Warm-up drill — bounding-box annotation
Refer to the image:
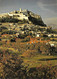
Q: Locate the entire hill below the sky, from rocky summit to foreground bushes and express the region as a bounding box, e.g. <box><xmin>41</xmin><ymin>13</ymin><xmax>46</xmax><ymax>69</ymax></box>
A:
<box><xmin>0</xmin><ymin>9</ymin><xmax>57</xmax><ymax>79</ymax></box>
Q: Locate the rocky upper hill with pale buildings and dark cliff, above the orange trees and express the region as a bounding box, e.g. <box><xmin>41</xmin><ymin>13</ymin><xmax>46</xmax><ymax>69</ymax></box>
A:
<box><xmin>0</xmin><ymin>9</ymin><xmax>53</xmax><ymax>38</ymax></box>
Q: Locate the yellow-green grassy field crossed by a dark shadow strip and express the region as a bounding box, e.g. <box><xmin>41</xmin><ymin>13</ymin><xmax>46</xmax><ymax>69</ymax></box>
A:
<box><xmin>23</xmin><ymin>55</ymin><xmax>57</xmax><ymax>68</ymax></box>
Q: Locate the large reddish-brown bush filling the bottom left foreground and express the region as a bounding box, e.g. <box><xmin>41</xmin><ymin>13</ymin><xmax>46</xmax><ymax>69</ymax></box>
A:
<box><xmin>0</xmin><ymin>49</ymin><xmax>26</xmax><ymax>79</ymax></box>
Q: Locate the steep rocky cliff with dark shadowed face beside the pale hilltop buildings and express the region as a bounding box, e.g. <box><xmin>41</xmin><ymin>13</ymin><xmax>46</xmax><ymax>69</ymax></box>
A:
<box><xmin>28</xmin><ymin>11</ymin><xmax>46</xmax><ymax>26</ymax></box>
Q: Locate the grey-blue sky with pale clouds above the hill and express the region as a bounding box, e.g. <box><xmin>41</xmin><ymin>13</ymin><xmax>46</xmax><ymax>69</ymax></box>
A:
<box><xmin>0</xmin><ymin>0</ymin><xmax>57</xmax><ymax>25</ymax></box>
